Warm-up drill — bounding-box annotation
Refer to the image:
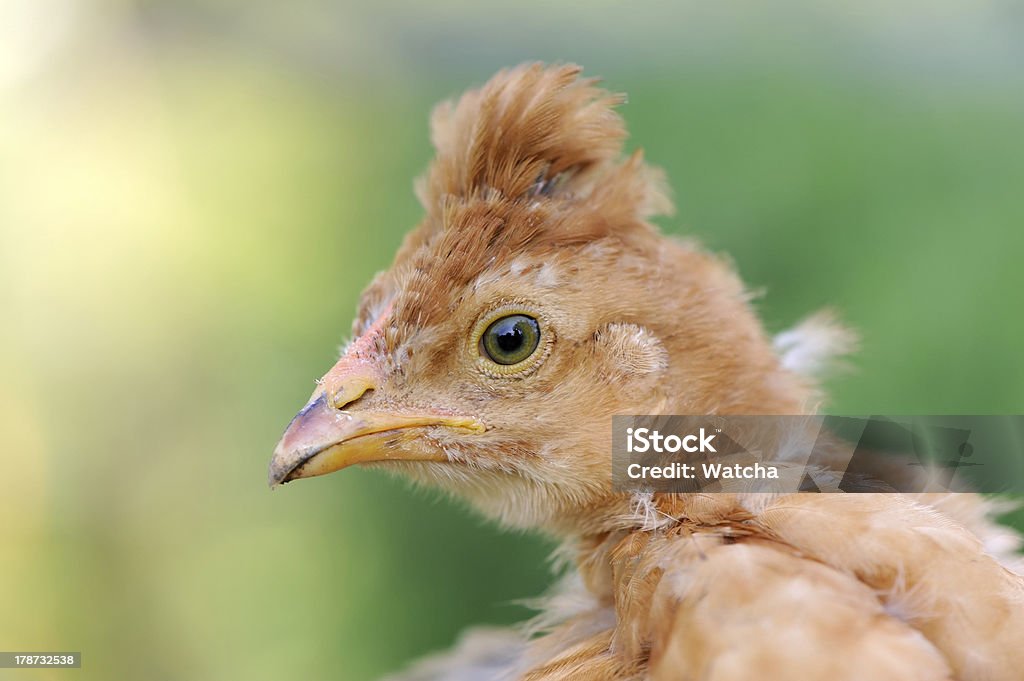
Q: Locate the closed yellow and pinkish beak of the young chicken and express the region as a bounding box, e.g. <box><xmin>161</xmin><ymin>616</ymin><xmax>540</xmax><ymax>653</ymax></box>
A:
<box><xmin>269</xmin><ymin>393</ymin><xmax>484</xmax><ymax>487</ymax></box>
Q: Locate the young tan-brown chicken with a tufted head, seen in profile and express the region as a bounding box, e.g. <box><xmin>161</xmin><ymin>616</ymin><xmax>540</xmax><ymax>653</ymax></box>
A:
<box><xmin>270</xmin><ymin>65</ymin><xmax>1024</xmax><ymax>681</ymax></box>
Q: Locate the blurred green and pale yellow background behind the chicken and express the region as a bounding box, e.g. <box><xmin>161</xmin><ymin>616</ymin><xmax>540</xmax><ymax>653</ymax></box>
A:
<box><xmin>0</xmin><ymin>0</ymin><xmax>1024</xmax><ymax>681</ymax></box>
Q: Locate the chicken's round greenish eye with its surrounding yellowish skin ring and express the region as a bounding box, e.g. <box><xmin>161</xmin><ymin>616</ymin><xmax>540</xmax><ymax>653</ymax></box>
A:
<box><xmin>470</xmin><ymin>305</ymin><xmax>553</xmax><ymax>378</ymax></box>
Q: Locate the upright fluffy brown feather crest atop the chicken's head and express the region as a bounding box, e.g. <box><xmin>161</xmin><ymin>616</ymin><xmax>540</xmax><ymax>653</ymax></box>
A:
<box><xmin>417</xmin><ymin>63</ymin><xmax>671</xmax><ymax>217</ymax></box>
